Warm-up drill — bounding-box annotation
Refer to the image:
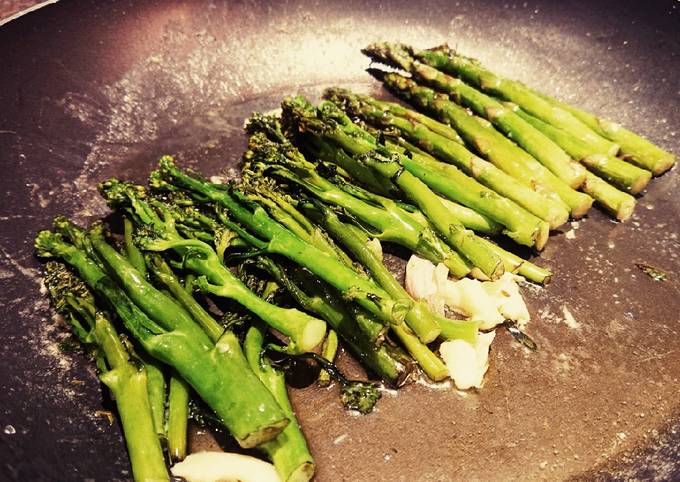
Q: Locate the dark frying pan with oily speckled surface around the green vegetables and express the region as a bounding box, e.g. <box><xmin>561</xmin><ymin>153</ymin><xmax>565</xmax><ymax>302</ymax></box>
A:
<box><xmin>0</xmin><ymin>0</ymin><xmax>680</xmax><ymax>481</ymax></box>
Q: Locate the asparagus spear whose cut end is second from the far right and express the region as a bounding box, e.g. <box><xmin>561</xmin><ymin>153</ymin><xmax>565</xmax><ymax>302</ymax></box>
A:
<box><xmin>517</xmin><ymin>108</ymin><xmax>652</xmax><ymax>194</ymax></box>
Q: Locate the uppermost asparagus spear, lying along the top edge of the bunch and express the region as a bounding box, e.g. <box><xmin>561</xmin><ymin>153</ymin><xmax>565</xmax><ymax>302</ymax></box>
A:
<box><xmin>412</xmin><ymin>46</ymin><xmax>619</xmax><ymax>155</ymax></box>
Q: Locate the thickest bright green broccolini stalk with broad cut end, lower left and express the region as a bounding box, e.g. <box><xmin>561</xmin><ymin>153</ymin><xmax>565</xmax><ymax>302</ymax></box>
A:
<box><xmin>35</xmin><ymin>224</ymin><xmax>288</xmax><ymax>447</ymax></box>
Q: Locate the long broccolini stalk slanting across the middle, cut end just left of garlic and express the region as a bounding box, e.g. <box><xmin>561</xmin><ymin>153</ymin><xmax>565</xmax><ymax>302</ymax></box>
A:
<box><xmin>151</xmin><ymin>156</ymin><xmax>410</xmax><ymax>324</ymax></box>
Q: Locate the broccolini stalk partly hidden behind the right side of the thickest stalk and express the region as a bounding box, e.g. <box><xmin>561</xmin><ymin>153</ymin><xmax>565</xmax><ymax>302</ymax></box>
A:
<box><xmin>243</xmin><ymin>322</ymin><xmax>314</xmax><ymax>482</ymax></box>
